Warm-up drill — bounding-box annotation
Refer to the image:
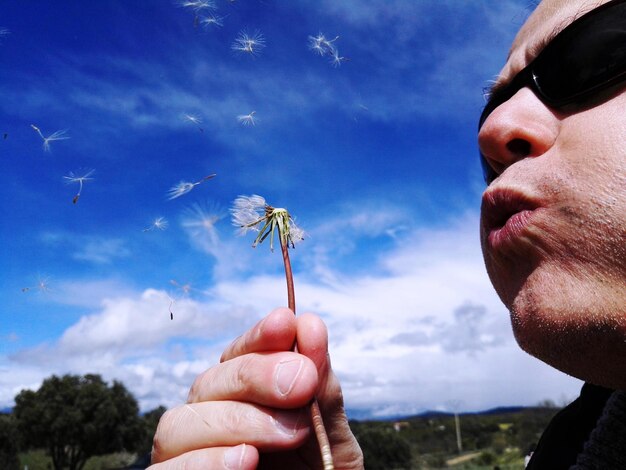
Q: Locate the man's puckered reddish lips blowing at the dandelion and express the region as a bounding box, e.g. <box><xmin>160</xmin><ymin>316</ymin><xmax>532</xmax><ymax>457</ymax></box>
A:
<box><xmin>481</xmin><ymin>188</ymin><xmax>539</xmax><ymax>251</ymax></box>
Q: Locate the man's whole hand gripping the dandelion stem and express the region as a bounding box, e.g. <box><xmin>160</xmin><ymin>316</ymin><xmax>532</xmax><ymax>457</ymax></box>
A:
<box><xmin>150</xmin><ymin>308</ymin><xmax>363</xmax><ymax>470</ymax></box>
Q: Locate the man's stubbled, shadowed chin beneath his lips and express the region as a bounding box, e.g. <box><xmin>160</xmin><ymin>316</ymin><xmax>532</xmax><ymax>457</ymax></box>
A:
<box><xmin>501</xmin><ymin>270</ymin><xmax>626</xmax><ymax>389</ymax></box>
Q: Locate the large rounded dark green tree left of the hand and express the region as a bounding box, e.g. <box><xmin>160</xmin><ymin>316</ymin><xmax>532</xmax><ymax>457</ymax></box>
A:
<box><xmin>13</xmin><ymin>374</ymin><xmax>144</xmax><ymax>470</ymax></box>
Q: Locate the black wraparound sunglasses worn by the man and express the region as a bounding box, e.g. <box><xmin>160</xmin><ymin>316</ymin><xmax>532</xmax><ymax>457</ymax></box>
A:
<box><xmin>478</xmin><ymin>0</ymin><xmax>626</xmax><ymax>184</ymax></box>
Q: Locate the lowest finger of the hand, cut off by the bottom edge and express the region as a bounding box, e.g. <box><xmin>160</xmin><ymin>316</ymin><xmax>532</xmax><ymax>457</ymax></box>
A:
<box><xmin>148</xmin><ymin>444</ymin><xmax>259</xmax><ymax>470</ymax></box>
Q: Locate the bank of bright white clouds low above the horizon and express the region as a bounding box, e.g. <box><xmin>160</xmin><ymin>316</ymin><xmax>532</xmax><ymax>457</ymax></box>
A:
<box><xmin>0</xmin><ymin>214</ymin><xmax>579</xmax><ymax>414</ymax></box>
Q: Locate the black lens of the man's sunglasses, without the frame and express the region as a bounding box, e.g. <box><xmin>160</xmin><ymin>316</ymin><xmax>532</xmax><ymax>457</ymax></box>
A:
<box><xmin>533</xmin><ymin>3</ymin><xmax>626</xmax><ymax>106</ymax></box>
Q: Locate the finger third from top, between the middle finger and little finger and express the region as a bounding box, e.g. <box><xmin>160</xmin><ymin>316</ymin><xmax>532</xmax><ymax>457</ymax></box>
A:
<box><xmin>152</xmin><ymin>401</ymin><xmax>310</xmax><ymax>463</ymax></box>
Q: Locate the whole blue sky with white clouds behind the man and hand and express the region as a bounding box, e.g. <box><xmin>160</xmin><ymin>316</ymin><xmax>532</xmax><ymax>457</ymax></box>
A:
<box><xmin>0</xmin><ymin>0</ymin><xmax>580</xmax><ymax>416</ymax></box>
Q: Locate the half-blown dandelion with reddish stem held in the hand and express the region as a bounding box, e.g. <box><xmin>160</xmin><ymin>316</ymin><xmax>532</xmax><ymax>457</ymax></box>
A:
<box><xmin>231</xmin><ymin>195</ymin><xmax>326</xmax><ymax>470</ymax></box>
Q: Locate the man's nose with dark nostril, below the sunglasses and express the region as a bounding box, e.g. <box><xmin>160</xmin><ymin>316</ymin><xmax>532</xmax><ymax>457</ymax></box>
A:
<box><xmin>478</xmin><ymin>88</ymin><xmax>559</xmax><ymax>179</ymax></box>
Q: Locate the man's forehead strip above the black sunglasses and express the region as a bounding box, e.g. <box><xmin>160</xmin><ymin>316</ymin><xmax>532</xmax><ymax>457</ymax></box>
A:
<box><xmin>499</xmin><ymin>0</ymin><xmax>610</xmax><ymax>81</ymax></box>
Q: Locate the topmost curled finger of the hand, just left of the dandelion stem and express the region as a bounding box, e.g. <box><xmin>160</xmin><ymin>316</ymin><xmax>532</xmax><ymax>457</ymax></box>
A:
<box><xmin>220</xmin><ymin>308</ymin><xmax>296</xmax><ymax>362</ymax></box>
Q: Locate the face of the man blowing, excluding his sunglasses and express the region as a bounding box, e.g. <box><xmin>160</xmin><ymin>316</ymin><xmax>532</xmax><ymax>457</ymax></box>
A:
<box><xmin>478</xmin><ymin>0</ymin><xmax>626</xmax><ymax>388</ymax></box>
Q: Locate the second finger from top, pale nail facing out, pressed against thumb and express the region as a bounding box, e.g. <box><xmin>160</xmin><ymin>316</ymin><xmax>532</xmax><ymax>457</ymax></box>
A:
<box><xmin>187</xmin><ymin>352</ymin><xmax>318</xmax><ymax>408</ymax></box>
